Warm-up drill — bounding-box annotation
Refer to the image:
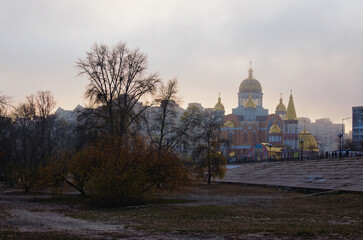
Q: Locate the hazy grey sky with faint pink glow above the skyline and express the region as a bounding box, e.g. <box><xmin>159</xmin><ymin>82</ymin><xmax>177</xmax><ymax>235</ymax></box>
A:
<box><xmin>0</xmin><ymin>0</ymin><xmax>363</xmax><ymax>130</ymax></box>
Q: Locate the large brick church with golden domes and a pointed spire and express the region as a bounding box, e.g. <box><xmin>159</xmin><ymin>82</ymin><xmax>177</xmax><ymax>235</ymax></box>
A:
<box><xmin>214</xmin><ymin>66</ymin><xmax>318</xmax><ymax>161</ymax></box>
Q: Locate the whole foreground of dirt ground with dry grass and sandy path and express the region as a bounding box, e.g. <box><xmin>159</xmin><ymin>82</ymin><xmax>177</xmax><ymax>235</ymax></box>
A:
<box><xmin>0</xmin><ymin>184</ymin><xmax>363</xmax><ymax>240</ymax></box>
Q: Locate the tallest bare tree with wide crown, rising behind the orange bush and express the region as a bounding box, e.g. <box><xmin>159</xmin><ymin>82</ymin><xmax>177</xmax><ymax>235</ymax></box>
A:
<box><xmin>76</xmin><ymin>42</ymin><xmax>159</xmax><ymax>137</ymax></box>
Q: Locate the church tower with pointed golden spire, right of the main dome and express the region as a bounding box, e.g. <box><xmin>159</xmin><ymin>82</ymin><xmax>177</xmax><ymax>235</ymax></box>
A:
<box><xmin>284</xmin><ymin>92</ymin><xmax>299</xmax><ymax>149</ymax></box>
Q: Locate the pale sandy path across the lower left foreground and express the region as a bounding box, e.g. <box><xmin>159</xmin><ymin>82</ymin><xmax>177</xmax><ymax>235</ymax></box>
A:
<box><xmin>0</xmin><ymin>187</ymin><xmax>144</xmax><ymax>239</ymax></box>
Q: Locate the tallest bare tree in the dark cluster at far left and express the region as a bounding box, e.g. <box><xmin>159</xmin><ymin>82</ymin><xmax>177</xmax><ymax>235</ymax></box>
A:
<box><xmin>13</xmin><ymin>91</ymin><xmax>56</xmax><ymax>192</ymax></box>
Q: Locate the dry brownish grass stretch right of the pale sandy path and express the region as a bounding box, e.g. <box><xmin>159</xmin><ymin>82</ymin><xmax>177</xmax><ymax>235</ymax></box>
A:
<box><xmin>62</xmin><ymin>184</ymin><xmax>363</xmax><ymax>239</ymax></box>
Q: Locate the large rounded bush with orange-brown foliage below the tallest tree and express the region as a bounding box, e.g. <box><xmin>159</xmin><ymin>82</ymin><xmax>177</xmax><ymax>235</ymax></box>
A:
<box><xmin>69</xmin><ymin>137</ymin><xmax>190</xmax><ymax>206</ymax></box>
